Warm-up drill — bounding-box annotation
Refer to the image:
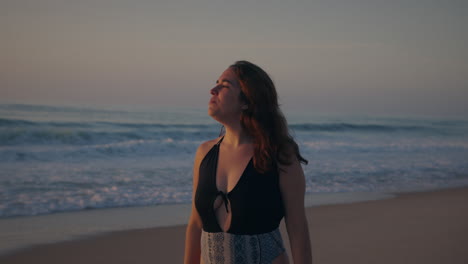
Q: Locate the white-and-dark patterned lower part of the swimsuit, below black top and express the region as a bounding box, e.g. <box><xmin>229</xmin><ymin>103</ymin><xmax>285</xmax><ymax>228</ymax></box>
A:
<box><xmin>201</xmin><ymin>228</ymin><xmax>285</xmax><ymax>264</ymax></box>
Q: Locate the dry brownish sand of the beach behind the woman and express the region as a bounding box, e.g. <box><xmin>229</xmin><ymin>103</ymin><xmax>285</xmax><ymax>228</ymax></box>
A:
<box><xmin>0</xmin><ymin>187</ymin><xmax>468</xmax><ymax>264</ymax></box>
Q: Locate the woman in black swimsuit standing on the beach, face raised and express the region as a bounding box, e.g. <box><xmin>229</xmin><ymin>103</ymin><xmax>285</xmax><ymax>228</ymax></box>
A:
<box><xmin>185</xmin><ymin>61</ymin><xmax>312</xmax><ymax>264</ymax></box>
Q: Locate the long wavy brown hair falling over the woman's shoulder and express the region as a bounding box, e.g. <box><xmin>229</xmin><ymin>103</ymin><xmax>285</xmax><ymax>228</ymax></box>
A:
<box><xmin>220</xmin><ymin>61</ymin><xmax>308</xmax><ymax>173</ymax></box>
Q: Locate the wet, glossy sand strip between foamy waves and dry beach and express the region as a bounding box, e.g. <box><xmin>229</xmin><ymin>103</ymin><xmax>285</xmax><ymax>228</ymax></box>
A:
<box><xmin>0</xmin><ymin>189</ymin><xmax>394</xmax><ymax>255</ymax></box>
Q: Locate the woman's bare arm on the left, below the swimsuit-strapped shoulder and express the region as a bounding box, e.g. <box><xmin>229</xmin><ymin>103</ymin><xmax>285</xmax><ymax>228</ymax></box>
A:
<box><xmin>184</xmin><ymin>144</ymin><xmax>203</xmax><ymax>264</ymax></box>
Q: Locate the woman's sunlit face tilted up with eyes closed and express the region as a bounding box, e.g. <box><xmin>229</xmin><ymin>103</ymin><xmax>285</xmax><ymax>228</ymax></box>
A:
<box><xmin>208</xmin><ymin>68</ymin><xmax>244</xmax><ymax>121</ymax></box>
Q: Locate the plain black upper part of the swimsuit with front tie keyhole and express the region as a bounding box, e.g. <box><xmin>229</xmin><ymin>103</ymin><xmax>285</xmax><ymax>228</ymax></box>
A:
<box><xmin>195</xmin><ymin>136</ymin><xmax>284</xmax><ymax>235</ymax></box>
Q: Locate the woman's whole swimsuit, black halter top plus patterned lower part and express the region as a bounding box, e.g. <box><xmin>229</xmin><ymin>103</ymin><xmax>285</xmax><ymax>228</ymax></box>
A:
<box><xmin>195</xmin><ymin>137</ymin><xmax>285</xmax><ymax>264</ymax></box>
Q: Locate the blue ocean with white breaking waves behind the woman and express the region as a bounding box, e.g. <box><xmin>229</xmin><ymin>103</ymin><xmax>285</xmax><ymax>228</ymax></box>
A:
<box><xmin>0</xmin><ymin>104</ymin><xmax>468</xmax><ymax>219</ymax></box>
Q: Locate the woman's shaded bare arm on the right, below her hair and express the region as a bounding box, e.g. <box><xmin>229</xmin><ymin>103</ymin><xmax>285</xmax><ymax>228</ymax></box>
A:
<box><xmin>280</xmin><ymin>157</ymin><xmax>312</xmax><ymax>264</ymax></box>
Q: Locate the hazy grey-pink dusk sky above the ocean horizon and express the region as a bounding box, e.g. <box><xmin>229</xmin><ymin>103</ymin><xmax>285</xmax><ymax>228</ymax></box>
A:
<box><xmin>0</xmin><ymin>0</ymin><xmax>468</xmax><ymax>118</ymax></box>
